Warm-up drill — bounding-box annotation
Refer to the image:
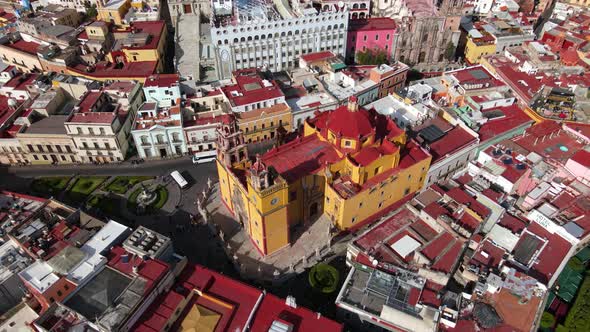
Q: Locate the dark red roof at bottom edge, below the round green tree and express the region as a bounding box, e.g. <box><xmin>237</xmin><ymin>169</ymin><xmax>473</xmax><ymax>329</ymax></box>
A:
<box><xmin>251</xmin><ymin>294</ymin><xmax>343</xmax><ymax>332</ymax></box>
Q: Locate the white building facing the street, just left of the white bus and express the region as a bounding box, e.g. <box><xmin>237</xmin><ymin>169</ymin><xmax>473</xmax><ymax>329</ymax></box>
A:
<box><xmin>131</xmin><ymin>102</ymin><xmax>188</xmax><ymax>158</ymax></box>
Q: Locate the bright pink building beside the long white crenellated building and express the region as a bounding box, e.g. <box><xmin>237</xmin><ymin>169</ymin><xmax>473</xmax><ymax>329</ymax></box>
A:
<box><xmin>346</xmin><ymin>17</ymin><xmax>396</xmax><ymax>63</ymax></box>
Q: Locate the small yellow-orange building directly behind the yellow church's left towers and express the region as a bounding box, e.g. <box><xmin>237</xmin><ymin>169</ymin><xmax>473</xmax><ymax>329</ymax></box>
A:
<box><xmin>235</xmin><ymin>103</ymin><xmax>293</xmax><ymax>143</ymax></box>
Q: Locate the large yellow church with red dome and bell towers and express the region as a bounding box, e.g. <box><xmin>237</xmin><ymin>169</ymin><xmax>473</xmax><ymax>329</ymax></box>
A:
<box><xmin>217</xmin><ymin>97</ymin><xmax>431</xmax><ymax>255</ymax></box>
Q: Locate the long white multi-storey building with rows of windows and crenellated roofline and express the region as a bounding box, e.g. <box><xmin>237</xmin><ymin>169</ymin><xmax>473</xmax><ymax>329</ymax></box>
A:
<box><xmin>211</xmin><ymin>0</ymin><xmax>348</xmax><ymax>79</ymax></box>
